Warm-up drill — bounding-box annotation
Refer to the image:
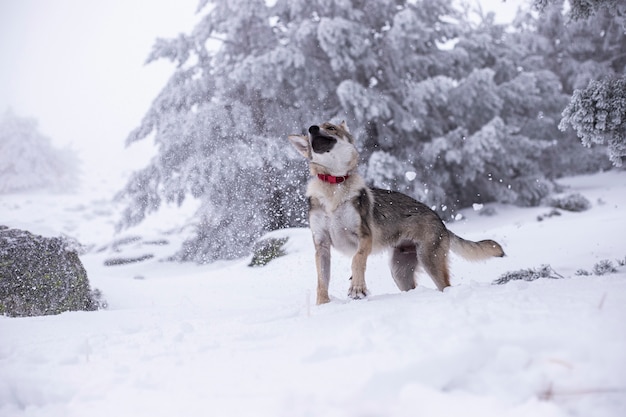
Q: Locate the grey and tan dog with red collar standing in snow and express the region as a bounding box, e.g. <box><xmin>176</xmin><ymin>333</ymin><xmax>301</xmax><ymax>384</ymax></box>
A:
<box><xmin>288</xmin><ymin>121</ymin><xmax>504</xmax><ymax>304</ymax></box>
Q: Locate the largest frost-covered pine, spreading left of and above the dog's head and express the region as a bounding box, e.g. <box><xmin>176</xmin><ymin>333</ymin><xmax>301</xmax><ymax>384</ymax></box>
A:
<box><xmin>120</xmin><ymin>0</ymin><xmax>468</xmax><ymax>262</ymax></box>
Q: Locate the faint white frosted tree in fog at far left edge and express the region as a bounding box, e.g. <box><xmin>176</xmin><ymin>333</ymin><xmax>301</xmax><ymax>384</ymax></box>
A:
<box><xmin>0</xmin><ymin>110</ymin><xmax>78</xmax><ymax>193</ymax></box>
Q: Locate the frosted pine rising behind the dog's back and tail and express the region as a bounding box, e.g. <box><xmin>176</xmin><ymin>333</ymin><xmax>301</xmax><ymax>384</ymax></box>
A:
<box><xmin>376</xmin><ymin>11</ymin><xmax>564</xmax><ymax>213</ymax></box>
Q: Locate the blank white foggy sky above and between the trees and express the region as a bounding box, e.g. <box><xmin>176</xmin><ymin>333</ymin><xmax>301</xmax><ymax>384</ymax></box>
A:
<box><xmin>0</xmin><ymin>0</ymin><xmax>525</xmax><ymax>192</ymax></box>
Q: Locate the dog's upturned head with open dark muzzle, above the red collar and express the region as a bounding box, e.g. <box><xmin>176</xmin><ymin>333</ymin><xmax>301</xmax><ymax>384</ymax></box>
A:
<box><xmin>289</xmin><ymin>122</ymin><xmax>359</xmax><ymax>176</ymax></box>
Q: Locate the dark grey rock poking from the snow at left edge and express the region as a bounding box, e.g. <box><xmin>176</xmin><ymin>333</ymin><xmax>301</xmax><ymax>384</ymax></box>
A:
<box><xmin>0</xmin><ymin>226</ymin><xmax>106</xmax><ymax>317</ymax></box>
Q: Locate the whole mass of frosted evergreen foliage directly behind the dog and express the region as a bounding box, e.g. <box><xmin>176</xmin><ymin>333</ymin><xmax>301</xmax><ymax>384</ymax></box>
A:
<box><xmin>120</xmin><ymin>0</ymin><xmax>623</xmax><ymax>262</ymax></box>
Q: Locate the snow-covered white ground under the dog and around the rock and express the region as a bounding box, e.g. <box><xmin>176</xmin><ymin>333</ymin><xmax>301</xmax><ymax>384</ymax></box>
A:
<box><xmin>0</xmin><ymin>171</ymin><xmax>626</xmax><ymax>417</ymax></box>
